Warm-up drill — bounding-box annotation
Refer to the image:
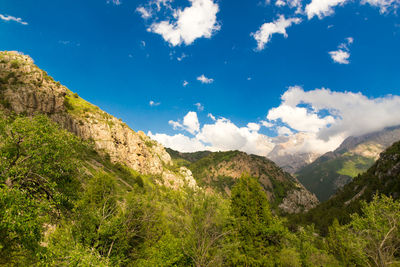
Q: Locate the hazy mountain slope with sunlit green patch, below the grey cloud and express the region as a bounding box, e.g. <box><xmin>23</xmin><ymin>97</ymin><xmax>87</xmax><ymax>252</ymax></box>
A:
<box><xmin>295</xmin><ymin>126</ymin><xmax>400</xmax><ymax>201</ymax></box>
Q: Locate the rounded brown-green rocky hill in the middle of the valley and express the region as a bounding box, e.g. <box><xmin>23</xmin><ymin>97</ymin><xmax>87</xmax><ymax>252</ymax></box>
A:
<box><xmin>167</xmin><ymin>149</ymin><xmax>318</xmax><ymax>213</ymax></box>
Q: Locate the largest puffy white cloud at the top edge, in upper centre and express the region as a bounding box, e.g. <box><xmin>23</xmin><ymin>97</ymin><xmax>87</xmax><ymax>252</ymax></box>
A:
<box><xmin>148</xmin><ymin>0</ymin><xmax>220</xmax><ymax>46</ymax></box>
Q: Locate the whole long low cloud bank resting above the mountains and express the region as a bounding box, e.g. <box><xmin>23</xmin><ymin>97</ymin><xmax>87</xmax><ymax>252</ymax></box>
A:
<box><xmin>151</xmin><ymin>86</ymin><xmax>400</xmax><ymax>159</ymax></box>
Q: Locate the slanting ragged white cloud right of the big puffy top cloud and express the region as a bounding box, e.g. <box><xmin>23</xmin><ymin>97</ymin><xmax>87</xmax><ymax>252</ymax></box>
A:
<box><xmin>251</xmin><ymin>15</ymin><xmax>301</xmax><ymax>51</ymax></box>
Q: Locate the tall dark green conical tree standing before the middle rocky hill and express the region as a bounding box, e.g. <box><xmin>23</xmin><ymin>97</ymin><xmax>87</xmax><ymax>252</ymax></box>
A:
<box><xmin>231</xmin><ymin>176</ymin><xmax>286</xmax><ymax>266</ymax></box>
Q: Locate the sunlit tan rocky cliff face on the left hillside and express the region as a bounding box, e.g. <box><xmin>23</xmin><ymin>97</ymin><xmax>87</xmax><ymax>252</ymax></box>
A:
<box><xmin>0</xmin><ymin>52</ymin><xmax>172</xmax><ymax>174</ymax></box>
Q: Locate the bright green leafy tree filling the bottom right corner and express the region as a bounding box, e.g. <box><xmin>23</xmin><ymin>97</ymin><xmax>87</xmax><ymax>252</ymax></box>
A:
<box><xmin>328</xmin><ymin>196</ymin><xmax>400</xmax><ymax>266</ymax></box>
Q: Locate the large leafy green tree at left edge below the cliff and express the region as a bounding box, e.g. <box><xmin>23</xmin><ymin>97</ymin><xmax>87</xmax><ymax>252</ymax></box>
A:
<box><xmin>0</xmin><ymin>116</ymin><xmax>84</xmax><ymax>209</ymax></box>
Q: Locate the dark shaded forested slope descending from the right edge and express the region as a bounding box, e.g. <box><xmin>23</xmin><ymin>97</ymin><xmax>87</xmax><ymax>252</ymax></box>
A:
<box><xmin>294</xmin><ymin>139</ymin><xmax>400</xmax><ymax>236</ymax></box>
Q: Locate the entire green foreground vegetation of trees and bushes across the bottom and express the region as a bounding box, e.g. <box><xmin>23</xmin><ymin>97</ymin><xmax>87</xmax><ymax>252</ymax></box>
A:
<box><xmin>0</xmin><ymin>114</ymin><xmax>400</xmax><ymax>266</ymax></box>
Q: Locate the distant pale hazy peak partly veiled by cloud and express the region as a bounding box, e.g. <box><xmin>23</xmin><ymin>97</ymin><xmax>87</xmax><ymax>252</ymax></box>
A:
<box><xmin>267</xmin><ymin>133</ymin><xmax>321</xmax><ymax>173</ymax></box>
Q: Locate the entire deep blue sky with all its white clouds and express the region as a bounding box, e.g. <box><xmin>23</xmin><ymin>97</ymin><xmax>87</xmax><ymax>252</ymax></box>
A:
<box><xmin>0</xmin><ymin>0</ymin><xmax>400</xmax><ymax>156</ymax></box>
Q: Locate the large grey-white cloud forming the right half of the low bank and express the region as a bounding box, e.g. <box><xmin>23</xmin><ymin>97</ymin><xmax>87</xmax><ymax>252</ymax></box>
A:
<box><xmin>268</xmin><ymin>86</ymin><xmax>400</xmax><ymax>141</ymax></box>
